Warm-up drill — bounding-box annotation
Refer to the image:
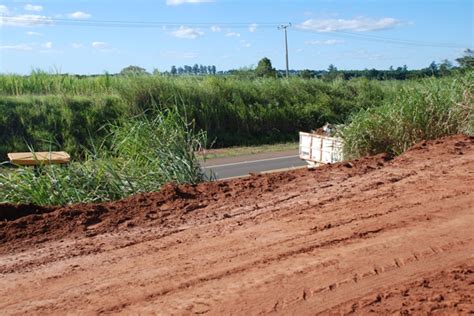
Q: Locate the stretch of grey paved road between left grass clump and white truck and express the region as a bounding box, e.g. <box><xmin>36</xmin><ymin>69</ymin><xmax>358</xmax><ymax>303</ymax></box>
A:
<box><xmin>202</xmin><ymin>150</ymin><xmax>306</xmax><ymax>179</ymax></box>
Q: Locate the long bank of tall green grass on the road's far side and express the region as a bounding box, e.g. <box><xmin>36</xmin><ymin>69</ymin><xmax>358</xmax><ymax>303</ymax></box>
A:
<box><xmin>0</xmin><ymin>71</ymin><xmax>386</xmax><ymax>161</ymax></box>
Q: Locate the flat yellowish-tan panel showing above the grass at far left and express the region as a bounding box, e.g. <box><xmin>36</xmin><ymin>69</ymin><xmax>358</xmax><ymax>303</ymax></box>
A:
<box><xmin>8</xmin><ymin>151</ymin><xmax>71</xmax><ymax>166</ymax></box>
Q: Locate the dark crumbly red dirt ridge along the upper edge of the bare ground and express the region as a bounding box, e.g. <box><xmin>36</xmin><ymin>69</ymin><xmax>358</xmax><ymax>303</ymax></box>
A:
<box><xmin>0</xmin><ymin>155</ymin><xmax>390</xmax><ymax>249</ymax></box>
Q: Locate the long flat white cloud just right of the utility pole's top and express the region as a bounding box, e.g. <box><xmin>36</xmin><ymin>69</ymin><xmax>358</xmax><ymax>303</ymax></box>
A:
<box><xmin>297</xmin><ymin>17</ymin><xmax>401</xmax><ymax>32</ymax></box>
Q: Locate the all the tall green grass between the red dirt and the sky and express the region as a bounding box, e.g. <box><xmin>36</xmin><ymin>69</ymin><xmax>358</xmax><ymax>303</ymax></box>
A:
<box><xmin>0</xmin><ymin>72</ymin><xmax>474</xmax><ymax>205</ymax></box>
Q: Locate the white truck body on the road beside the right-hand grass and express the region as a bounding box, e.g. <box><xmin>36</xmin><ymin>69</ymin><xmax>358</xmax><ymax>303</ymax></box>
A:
<box><xmin>299</xmin><ymin>132</ymin><xmax>344</xmax><ymax>167</ymax></box>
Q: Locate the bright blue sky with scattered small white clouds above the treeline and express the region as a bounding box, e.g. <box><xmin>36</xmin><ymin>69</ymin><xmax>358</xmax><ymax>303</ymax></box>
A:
<box><xmin>0</xmin><ymin>0</ymin><xmax>474</xmax><ymax>74</ymax></box>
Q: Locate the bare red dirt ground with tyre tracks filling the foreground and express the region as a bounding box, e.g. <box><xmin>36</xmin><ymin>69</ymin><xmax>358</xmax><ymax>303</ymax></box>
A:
<box><xmin>0</xmin><ymin>136</ymin><xmax>474</xmax><ymax>315</ymax></box>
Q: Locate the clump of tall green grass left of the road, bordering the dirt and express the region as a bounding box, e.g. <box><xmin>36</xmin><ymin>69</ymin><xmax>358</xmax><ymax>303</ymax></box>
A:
<box><xmin>0</xmin><ymin>110</ymin><xmax>205</xmax><ymax>205</ymax></box>
